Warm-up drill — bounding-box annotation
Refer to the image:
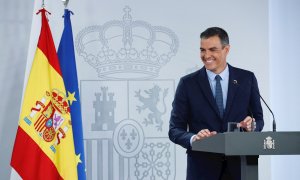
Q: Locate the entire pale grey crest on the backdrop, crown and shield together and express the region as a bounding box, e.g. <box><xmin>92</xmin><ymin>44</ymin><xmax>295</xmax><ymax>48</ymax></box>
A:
<box><xmin>76</xmin><ymin>6</ymin><xmax>179</xmax><ymax>180</ymax></box>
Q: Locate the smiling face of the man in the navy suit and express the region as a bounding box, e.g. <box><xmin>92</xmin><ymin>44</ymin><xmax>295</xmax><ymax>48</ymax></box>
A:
<box><xmin>200</xmin><ymin>36</ymin><xmax>230</xmax><ymax>74</ymax></box>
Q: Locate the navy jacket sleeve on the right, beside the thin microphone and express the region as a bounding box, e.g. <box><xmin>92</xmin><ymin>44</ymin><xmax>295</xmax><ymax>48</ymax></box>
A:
<box><xmin>250</xmin><ymin>74</ymin><xmax>264</xmax><ymax>131</ymax></box>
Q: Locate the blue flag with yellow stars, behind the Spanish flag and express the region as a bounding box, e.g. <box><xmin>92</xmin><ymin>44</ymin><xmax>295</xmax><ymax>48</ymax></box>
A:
<box><xmin>57</xmin><ymin>9</ymin><xmax>86</xmax><ymax>180</ymax></box>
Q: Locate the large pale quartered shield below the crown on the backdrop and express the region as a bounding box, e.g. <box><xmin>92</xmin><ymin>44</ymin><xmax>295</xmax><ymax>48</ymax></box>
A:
<box><xmin>81</xmin><ymin>80</ymin><xmax>175</xmax><ymax>180</ymax></box>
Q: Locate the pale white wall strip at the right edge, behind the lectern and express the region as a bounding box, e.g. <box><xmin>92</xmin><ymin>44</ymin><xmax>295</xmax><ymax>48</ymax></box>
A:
<box><xmin>269</xmin><ymin>0</ymin><xmax>300</xmax><ymax>180</ymax></box>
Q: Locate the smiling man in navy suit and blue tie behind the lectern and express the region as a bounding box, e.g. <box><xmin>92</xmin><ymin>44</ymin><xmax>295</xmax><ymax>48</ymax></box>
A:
<box><xmin>169</xmin><ymin>27</ymin><xmax>264</xmax><ymax>180</ymax></box>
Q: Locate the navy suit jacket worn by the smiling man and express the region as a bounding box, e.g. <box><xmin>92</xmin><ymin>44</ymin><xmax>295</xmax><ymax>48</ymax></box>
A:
<box><xmin>169</xmin><ymin>65</ymin><xmax>264</xmax><ymax>179</ymax></box>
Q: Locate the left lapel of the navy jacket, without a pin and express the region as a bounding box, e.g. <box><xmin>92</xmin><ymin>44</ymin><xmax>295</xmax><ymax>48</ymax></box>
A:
<box><xmin>197</xmin><ymin>67</ymin><xmax>219</xmax><ymax>115</ymax></box>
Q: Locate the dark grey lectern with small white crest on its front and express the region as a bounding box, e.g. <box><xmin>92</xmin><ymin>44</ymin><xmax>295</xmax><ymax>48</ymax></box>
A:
<box><xmin>192</xmin><ymin>132</ymin><xmax>300</xmax><ymax>180</ymax></box>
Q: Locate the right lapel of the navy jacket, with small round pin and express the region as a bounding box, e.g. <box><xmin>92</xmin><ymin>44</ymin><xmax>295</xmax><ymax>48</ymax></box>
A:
<box><xmin>224</xmin><ymin>65</ymin><xmax>239</xmax><ymax>120</ymax></box>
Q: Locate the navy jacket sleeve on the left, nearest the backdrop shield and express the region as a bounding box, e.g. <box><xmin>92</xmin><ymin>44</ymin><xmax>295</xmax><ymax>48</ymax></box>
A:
<box><xmin>169</xmin><ymin>79</ymin><xmax>194</xmax><ymax>149</ymax></box>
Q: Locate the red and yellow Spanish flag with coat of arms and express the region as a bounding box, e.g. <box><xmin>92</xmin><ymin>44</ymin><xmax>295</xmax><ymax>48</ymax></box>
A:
<box><xmin>11</xmin><ymin>8</ymin><xmax>80</xmax><ymax>180</ymax></box>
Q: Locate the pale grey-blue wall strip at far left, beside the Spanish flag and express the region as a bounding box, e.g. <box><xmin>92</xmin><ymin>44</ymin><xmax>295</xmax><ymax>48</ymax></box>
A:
<box><xmin>0</xmin><ymin>0</ymin><xmax>33</xmax><ymax>179</ymax></box>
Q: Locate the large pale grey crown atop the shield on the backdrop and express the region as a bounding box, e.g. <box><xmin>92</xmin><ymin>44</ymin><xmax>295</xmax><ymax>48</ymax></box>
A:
<box><xmin>76</xmin><ymin>6</ymin><xmax>179</xmax><ymax>79</ymax></box>
